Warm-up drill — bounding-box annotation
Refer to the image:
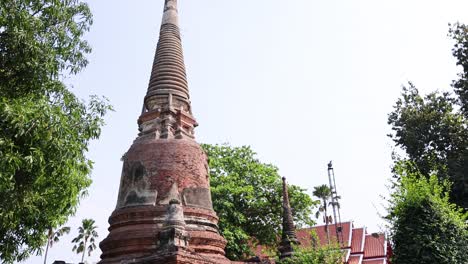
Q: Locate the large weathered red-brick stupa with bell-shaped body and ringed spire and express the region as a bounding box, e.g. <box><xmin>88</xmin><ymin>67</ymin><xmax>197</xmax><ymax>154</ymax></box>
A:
<box><xmin>99</xmin><ymin>0</ymin><xmax>231</xmax><ymax>264</ymax></box>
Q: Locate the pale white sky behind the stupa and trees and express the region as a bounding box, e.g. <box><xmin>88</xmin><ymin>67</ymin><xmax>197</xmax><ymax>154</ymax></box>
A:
<box><xmin>19</xmin><ymin>0</ymin><xmax>468</xmax><ymax>263</ymax></box>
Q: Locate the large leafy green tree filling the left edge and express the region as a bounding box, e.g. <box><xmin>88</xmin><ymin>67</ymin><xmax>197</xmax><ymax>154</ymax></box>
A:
<box><xmin>0</xmin><ymin>0</ymin><xmax>110</xmax><ymax>263</ymax></box>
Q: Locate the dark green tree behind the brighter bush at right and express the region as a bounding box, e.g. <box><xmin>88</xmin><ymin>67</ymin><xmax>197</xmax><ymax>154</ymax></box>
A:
<box><xmin>388</xmin><ymin>83</ymin><xmax>468</xmax><ymax>208</ymax></box>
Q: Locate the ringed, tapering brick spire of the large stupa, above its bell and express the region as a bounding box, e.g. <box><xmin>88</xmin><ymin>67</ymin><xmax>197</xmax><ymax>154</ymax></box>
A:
<box><xmin>138</xmin><ymin>0</ymin><xmax>197</xmax><ymax>138</ymax></box>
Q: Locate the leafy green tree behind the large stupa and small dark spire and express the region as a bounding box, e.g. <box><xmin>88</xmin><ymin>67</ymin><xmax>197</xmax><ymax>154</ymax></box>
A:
<box><xmin>202</xmin><ymin>144</ymin><xmax>316</xmax><ymax>260</ymax></box>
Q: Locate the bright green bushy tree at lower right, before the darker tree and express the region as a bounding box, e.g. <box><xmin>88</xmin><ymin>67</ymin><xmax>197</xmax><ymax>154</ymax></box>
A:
<box><xmin>386</xmin><ymin>162</ymin><xmax>468</xmax><ymax>264</ymax></box>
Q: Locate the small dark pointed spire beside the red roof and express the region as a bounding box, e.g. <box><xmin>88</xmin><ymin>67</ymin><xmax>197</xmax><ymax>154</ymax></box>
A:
<box><xmin>278</xmin><ymin>177</ymin><xmax>299</xmax><ymax>258</ymax></box>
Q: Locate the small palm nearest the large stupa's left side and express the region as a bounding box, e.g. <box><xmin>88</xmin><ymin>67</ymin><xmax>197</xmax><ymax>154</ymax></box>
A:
<box><xmin>72</xmin><ymin>219</ymin><xmax>98</xmax><ymax>262</ymax></box>
